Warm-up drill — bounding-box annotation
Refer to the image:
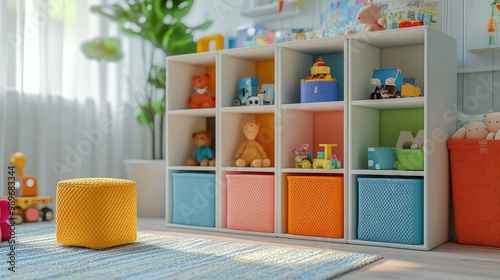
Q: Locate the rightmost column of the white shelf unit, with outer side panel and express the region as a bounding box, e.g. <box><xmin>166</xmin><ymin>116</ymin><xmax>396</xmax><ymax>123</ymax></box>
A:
<box><xmin>347</xmin><ymin>27</ymin><xmax>457</xmax><ymax>250</ymax></box>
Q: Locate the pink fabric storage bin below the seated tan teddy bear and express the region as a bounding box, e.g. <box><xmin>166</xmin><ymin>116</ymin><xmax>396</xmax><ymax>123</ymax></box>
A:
<box><xmin>226</xmin><ymin>174</ymin><xmax>274</xmax><ymax>232</ymax></box>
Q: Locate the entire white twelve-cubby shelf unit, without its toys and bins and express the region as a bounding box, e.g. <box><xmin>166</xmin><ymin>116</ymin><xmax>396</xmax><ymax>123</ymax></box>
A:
<box><xmin>166</xmin><ymin>26</ymin><xmax>456</xmax><ymax>250</ymax></box>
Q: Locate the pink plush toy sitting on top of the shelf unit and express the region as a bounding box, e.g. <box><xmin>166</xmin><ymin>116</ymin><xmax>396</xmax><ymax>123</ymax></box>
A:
<box><xmin>345</xmin><ymin>0</ymin><xmax>387</xmax><ymax>35</ymax></box>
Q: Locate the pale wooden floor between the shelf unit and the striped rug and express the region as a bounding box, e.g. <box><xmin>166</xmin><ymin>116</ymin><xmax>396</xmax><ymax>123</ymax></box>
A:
<box><xmin>138</xmin><ymin>218</ymin><xmax>500</xmax><ymax>280</ymax></box>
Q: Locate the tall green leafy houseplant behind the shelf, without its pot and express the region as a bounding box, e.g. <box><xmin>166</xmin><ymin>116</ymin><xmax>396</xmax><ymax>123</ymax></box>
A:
<box><xmin>82</xmin><ymin>0</ymin><xmax>212</xmax><ymax>159</ymax></box>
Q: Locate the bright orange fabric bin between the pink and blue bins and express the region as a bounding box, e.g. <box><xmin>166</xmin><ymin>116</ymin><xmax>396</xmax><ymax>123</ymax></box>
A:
<box><xmin>287</xmin><ymin>176</ymin><xmax>344</xmax><ymax>238</ymax></box>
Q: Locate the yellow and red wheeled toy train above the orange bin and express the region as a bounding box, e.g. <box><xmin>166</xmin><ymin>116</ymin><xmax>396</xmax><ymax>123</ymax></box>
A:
<box><xmin>292</xmin><ymin>144</ymin><xmax>342</xmax><ymax>169</ymax></box>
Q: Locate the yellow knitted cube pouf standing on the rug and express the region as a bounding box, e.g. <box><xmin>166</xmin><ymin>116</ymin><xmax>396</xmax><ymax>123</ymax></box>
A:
<box><xmin>56</xmin><ymin>178</ymin><xmax>137</xmax><ymax>249</ymax></box>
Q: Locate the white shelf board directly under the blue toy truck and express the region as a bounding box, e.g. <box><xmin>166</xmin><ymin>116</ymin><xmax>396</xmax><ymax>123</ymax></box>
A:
<box><xmin>351</xmin><ymin>97</ymin><xmax>425</xmax><ymax>109</ymax></box>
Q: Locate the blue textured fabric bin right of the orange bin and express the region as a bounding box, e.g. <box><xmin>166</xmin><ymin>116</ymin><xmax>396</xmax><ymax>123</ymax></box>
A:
<box><xmin>358</xmin><ymin>177</ymin><xmax>424</xmax><ymax>245</ymax></box>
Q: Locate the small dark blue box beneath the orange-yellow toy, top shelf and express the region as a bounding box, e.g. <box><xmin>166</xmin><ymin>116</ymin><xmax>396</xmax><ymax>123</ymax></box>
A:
<box><xmin>300</xmin><ymin>81</ymin><xmax>339</xmax><ymax>103</ymax></box>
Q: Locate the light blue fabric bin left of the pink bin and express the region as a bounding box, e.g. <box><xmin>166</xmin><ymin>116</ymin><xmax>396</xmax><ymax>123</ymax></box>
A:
<box><xmin>172</xmin><ymin>172</ymin><xmax>215</xmax><ymax>227</ymax></box>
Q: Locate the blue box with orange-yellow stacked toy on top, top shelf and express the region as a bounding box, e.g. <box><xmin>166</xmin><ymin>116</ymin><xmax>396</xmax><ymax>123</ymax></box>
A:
<box><xmin>300</xmin><ymin>56</ymin><xmax>339</xmax><ymax>103</ymax></box>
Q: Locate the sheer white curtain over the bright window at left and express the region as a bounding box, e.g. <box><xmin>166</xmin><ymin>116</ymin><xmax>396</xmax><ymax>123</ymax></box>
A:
<box><xmin>0</xmin><ymin>0</ymin><xmax>150</xmax><ymax>200</ymax></box>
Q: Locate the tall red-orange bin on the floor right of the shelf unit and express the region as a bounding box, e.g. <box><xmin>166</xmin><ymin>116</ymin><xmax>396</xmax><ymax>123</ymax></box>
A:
<box><xmin>447</xmin><ymin>140</ymin><xmax>500</xmax><ymax>247</ymax></box>
